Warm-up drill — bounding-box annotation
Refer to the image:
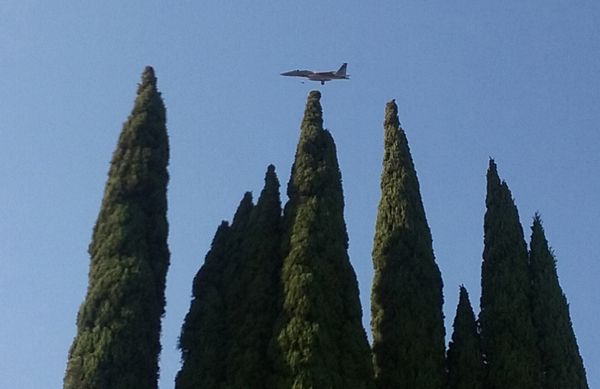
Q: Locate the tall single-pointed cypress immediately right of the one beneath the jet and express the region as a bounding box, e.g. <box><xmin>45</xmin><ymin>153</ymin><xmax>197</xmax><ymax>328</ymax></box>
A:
<box><xmin>371</xmin><ymin>100</ymin><xmax>445</xmax><ymax>389</ymax></box>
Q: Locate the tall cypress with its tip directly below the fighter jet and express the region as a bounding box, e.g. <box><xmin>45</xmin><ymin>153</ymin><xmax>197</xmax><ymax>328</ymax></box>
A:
<box><xmin>275</xmin><ymin>91</ymin><xmax>372</xmax><ymax>389</ymax></box>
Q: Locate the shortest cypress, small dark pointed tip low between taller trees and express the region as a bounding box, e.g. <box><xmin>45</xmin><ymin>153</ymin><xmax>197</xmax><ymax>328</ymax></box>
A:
<box><xmin>447</xmin><ymin>286</ymin><xmax>483</xmax><ymax>389</ymax></box>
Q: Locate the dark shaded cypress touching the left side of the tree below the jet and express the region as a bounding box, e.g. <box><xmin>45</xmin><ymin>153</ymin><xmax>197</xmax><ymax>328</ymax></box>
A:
<box><xmin>225</xmin><ymin>165</ymin><xmax>281</xmax><ymax>389</ymax></box>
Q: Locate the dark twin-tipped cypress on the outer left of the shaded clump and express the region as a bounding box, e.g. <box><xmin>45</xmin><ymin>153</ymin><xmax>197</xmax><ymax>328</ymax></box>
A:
<box><xmin>175</xmin><ymin>193</ymin><xmax>254</xmax><ymax>389</ymax></box>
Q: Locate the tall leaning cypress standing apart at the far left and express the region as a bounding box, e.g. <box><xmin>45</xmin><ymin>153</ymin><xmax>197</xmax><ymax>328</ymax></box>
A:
<box><xmin>64</xmin><ymin>67</ymin><xmax>169</xmax><ymax>389</ymax></box>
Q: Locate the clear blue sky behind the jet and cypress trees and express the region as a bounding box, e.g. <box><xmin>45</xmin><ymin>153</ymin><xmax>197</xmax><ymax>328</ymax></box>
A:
<box><xmin>0</xmin><ymin>0</ymin><xmax>600</xmax><ymax>389</ymax></box>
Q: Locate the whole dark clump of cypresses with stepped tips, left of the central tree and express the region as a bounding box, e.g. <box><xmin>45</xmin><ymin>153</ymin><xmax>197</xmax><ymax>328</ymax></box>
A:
<box><xmin>176</xmin><ymin>166</ymin><xmax>281</xmax><ymax>389</ymax></box>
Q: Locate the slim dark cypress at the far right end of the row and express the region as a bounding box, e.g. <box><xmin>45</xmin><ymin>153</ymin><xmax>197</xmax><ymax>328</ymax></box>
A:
<box><xmin>529</xmin><ymin>214</ymin><xmax>588</xmax><ymax>389</ymax></box>
